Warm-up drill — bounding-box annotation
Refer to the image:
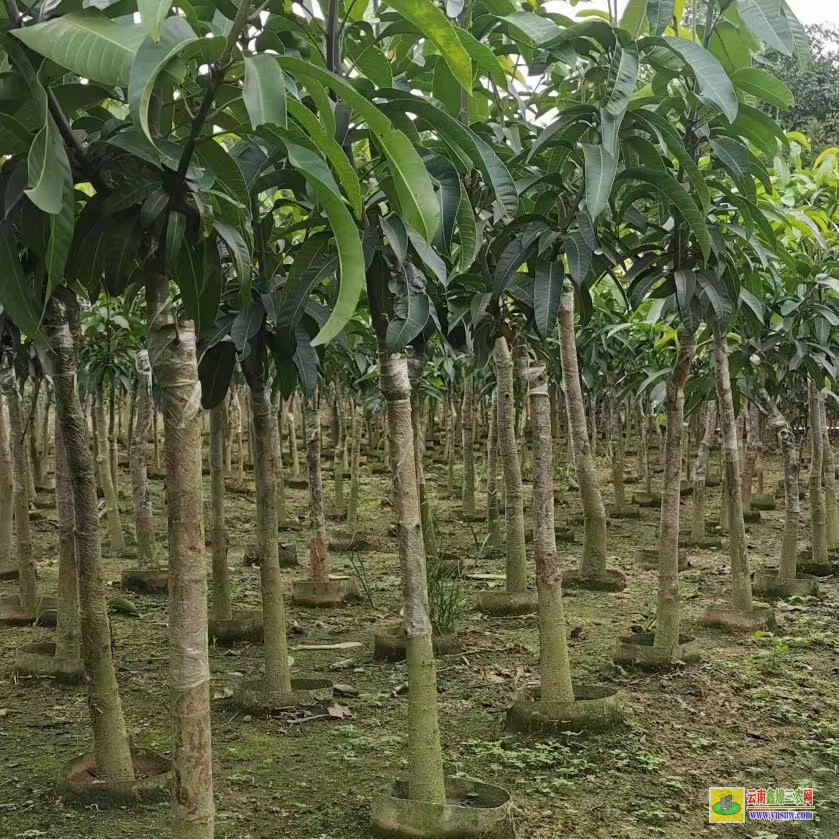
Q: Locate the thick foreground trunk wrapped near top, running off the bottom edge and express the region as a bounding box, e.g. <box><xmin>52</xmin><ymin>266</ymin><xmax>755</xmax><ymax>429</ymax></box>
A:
<box><xmin>146</xmin><ymin>272</ymin><xmax>212</xmax><ymax>839</ymax></box>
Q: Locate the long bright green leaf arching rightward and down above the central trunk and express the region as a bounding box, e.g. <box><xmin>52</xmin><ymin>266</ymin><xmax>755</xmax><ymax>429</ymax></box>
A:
<box><xmin>277</xmin><ymin>55</ymin><xmax>440</xmax><ymax>242</ymax></box>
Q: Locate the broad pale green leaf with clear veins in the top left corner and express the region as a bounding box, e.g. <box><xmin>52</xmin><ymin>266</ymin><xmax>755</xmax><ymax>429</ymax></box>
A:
<box><xmin>12</xmin><ymin>9</ymin><xmax>146</xmax><ymax>87</ymax></box>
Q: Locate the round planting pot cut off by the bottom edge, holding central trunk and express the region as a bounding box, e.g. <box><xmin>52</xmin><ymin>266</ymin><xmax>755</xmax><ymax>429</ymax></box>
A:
<box><xmin>372</xmin><ymin>778</ymin><xmax>516</xmax><ymax>839</ymax></box>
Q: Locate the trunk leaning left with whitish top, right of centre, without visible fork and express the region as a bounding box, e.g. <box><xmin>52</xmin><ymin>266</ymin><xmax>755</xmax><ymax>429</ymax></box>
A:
<box><xmin>559</xmin><ymin>280</ymin><xmax>606</xmax><ymax>579</ymax></box>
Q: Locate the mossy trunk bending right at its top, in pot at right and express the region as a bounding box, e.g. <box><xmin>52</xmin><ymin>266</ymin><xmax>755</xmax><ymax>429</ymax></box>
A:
<box><xmin>654</xmin><ymin>330</ymin><xmax>696</xmax><ymax>661</ymax></box>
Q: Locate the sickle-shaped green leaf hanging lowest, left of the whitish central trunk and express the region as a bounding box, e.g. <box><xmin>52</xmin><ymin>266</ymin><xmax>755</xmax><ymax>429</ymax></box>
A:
<box><xmin>287</xmin><ymin>143</ymin><xmax>364</xmax><ymax>347</ymax></box>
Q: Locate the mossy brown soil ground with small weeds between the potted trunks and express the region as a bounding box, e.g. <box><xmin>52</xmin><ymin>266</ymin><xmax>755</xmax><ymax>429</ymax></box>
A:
<box><xmin>0</xmin><ymin>436</ymin><xmax>839</xmax><ymax>839</ymax></box>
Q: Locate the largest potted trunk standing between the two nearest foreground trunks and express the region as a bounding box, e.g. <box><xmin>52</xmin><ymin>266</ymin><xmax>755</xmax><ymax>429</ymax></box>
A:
<box><xmin>248</xmin><ymin>370</ymin><xmax>291</xmax><ymax>703</ymax></box>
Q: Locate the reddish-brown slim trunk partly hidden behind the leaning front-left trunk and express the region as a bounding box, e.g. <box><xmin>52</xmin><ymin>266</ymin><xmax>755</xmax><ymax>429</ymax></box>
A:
<box><xmin>55</xmin><ymin>423</ymin><xmax>82</xmax><ymax>661</ymax></box>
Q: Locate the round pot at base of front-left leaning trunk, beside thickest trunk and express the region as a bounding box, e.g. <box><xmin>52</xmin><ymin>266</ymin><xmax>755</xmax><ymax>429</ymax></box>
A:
<box><xmin>56</xmin><ymin>749</ymin><xmax>172</xmax><ymax>806</ymax></box>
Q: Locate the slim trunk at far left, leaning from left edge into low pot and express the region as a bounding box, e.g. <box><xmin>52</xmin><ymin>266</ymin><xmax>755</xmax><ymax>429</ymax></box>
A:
<box><xmin>0</xmin><ymin>363</ymin><xmax>38</xmax><ymax>617</ymax></box>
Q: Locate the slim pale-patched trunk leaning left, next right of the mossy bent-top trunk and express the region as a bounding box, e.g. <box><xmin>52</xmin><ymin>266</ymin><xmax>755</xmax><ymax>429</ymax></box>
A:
<box><xmin>714</xmin><ymin>334</ymin><xmax>752</xmax><ymax>613</ymax></box>
